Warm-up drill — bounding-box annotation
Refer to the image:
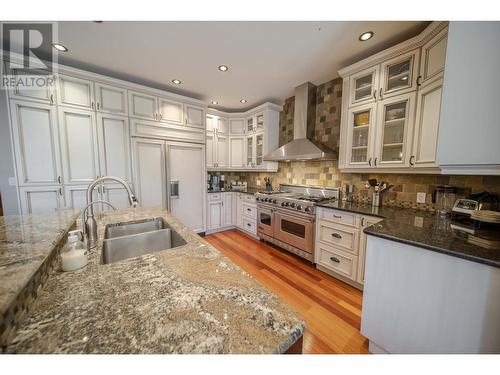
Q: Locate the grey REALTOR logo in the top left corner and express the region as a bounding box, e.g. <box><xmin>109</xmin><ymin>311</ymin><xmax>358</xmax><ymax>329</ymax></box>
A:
<box><xmin>0</xmin><ymin>22</ymin><xmax>57</xmax><ymax>92</ymax></box>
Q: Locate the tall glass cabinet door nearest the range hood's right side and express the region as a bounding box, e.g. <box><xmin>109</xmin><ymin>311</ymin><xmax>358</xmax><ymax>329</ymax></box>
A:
<box><xmin>347</xmin><ymin>103</ymin><xmax>376</xmax><ymax>168</ymax></box>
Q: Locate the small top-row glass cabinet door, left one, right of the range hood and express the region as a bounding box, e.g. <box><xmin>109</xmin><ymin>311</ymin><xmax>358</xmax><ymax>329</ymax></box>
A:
<box><xmin>349</xmin><ymin>66</ymin><xmax>379</xmax><ymax>107</ymax></box>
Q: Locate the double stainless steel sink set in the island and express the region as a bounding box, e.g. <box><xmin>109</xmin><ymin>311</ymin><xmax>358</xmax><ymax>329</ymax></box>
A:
<box><xmin>102</xmin><ymin>217</ymin><xmax>186</xmax><ymax>264</ymax></box>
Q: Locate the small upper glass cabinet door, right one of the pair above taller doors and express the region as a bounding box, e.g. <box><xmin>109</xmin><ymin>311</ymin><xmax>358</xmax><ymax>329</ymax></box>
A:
<box><xmin>377</xmin><ymin>51</ymin><xmax>418</xmax><ymax>99</ymax></box>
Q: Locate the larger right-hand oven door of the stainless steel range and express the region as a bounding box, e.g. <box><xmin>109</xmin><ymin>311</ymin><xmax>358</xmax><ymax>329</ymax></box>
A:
<box><xmin>274</xmin><ymin>211</ymin><xmax>314</xmax><ymax>254</ymax></box>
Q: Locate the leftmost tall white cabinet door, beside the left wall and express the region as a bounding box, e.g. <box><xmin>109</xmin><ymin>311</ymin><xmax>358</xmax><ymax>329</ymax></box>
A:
<box><xmin>10</xmin><ymin>100</ymin><xmax>62</xmax><ymax>185</ymax></box>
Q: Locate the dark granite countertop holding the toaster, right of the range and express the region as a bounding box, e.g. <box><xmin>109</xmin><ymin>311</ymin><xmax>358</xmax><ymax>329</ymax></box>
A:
<box><xmin>319</xmin><ymin>201</ymin><xmax>500</xmax><ymax>267</ymax></box>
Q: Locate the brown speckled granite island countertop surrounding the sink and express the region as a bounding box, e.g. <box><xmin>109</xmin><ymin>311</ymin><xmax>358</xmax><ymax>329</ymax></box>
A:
<box><xmin>6</xmin><ymin>209</ymin><xmax>305</xmax><ymax>353</ymax></box>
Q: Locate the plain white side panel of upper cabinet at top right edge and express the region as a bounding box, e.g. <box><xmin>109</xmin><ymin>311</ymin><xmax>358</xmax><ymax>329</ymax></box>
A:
<box><xmin>437</xmin><ymin>22</ymin><xmax>500</xmax><ymax>167</ymax></box>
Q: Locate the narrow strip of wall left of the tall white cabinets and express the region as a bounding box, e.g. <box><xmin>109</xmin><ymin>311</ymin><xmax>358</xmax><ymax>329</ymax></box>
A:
<box><xmin>0</xmin><ymin>89</ymin><xmax>19</xmax><ymax>215</ymax></box>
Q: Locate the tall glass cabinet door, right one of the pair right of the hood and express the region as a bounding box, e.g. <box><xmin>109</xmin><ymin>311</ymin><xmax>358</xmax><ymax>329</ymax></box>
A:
<box><xmin>373</xmin><ymin>93</ymin><xmax>416</xmax><ymax>168</ymax></box>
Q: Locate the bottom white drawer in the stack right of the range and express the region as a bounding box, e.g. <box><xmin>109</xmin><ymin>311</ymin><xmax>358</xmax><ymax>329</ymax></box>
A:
<box><xmin>316</xmin><ymin>243</ymin><xmax>358</xmax><ymax>280</ymax></box>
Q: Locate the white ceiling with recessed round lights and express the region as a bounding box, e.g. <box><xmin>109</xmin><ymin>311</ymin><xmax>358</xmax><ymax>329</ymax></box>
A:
<box><xmin>51</xmin><ymin>21</ymin><xmax>428</xmax><ymax>111</ymax></box>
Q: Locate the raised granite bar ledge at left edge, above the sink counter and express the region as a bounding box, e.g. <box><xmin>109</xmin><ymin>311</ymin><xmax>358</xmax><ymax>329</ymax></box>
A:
<box><xmin>0</xmin><ymin>210</ymin><xmax>78</xmax><ymax>318</ymax></box>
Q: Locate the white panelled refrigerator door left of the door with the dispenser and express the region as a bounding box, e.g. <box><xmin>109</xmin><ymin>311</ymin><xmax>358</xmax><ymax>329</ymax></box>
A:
<box><xmin>132</xmin><ymin>138</ymin><xmax>167</xmax><ymax>208</ymax></box>
